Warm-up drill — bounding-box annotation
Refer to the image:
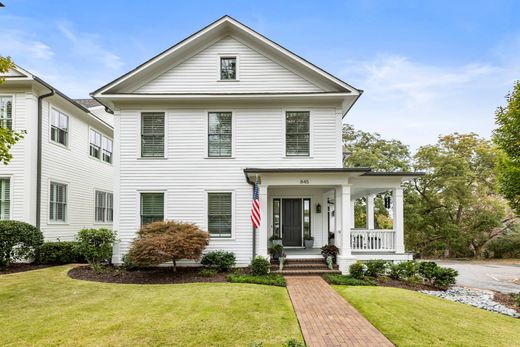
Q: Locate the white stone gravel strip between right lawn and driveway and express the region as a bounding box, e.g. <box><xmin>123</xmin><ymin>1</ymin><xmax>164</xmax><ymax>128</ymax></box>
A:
<box><xmin>420</xmin><ymin>287</ymin><xmax>520</xmax><ymax>318</ymax></box>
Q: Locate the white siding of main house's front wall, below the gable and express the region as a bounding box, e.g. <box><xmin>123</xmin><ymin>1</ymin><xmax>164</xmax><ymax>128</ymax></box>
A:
<box><xmin>114</xmin><ymin>105</ymin><xmax>341</xmax><ymax>265</ymax></box>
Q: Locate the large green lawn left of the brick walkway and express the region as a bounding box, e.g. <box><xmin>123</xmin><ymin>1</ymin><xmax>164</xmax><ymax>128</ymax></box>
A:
<box><xmin>0</xmin><ymin>266</ymin><xmax>302</xmax><ymax>346</ymax></box>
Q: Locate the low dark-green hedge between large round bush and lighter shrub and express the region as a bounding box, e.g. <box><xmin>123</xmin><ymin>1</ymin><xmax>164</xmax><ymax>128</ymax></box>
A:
<box><xmin>36</xmin><ymin>241</ymin><xmax>85</xmax><ymax>264</ymax></box>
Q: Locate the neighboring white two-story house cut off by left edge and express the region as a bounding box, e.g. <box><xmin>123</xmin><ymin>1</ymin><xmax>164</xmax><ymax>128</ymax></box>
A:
<box><xmin>0</xmin><ymin>67</ymin><xmax>114</xmax><ymax>241</ymax></box>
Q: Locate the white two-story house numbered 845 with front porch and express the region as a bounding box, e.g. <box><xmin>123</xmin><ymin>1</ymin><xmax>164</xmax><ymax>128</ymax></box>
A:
<box><xmin>92</xmin><ymin>16</ymin><xmax>420</xmax><ymax>272</ymax></box>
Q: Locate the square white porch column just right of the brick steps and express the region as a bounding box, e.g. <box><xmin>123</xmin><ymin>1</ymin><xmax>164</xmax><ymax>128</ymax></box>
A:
<box><xmin>336</xmin><ymin>184</ymin><xmax>355</xmax><ymax>274</ymax></box>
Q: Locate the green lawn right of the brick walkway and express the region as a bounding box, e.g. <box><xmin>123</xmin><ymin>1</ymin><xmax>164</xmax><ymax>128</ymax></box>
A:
<box><xmin>334</xmin><ymin>286</ymin><xmax>520</xmax><ymax>347</ymax></box>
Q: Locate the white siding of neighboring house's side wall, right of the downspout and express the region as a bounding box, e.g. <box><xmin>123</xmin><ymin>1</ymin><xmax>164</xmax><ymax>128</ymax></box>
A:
<box><xmin>41</xmin><ymin>97</ymin><xmax>113</xmax><ymax>241</ymax></box>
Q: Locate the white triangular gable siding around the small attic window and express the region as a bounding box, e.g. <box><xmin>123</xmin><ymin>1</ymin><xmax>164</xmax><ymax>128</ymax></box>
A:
<box><xmin>134</xmin><ymin>36</ymin><xmax>323</xmax><ymax>93</ymax></box>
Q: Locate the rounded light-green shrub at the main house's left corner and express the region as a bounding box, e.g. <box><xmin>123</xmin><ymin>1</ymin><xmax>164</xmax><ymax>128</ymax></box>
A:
<box><xmin>76</xmin><ymin>228</ymin><xmax>116</xmax><ymax>271</ymax></box>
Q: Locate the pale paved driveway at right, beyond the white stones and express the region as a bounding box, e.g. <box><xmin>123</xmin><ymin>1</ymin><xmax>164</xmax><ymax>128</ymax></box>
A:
<box><xmin>436</xmin><ymin>260</ymin><xmax>520</xmax><ymax>293</ymax></box>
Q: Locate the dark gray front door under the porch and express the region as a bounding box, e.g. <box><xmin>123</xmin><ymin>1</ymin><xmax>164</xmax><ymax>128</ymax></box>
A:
<box><xmin>282</xmin><ymin>199</ymin><xmax>302</xmax><ymax>247</ymax></box>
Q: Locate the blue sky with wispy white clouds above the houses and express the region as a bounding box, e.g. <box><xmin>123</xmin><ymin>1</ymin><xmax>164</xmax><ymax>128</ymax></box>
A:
<box><xmin>0</xmin><ymin>0</ymin><xmax>520</xmax><ymax>149</ymax></box>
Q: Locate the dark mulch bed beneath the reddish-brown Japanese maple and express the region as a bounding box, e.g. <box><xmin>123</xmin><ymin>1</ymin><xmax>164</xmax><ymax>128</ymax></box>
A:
<box><xmin>68</xmin><ymin>265</ymin><xmax>228</xmax><ymax>284</ymax></box>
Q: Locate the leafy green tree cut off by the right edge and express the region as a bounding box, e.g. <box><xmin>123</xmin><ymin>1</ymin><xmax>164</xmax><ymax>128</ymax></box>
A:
<box><xmin>493</xmin><ymin>81</ymin><xmax>520</xmax><ymax>213</ymax></box>
